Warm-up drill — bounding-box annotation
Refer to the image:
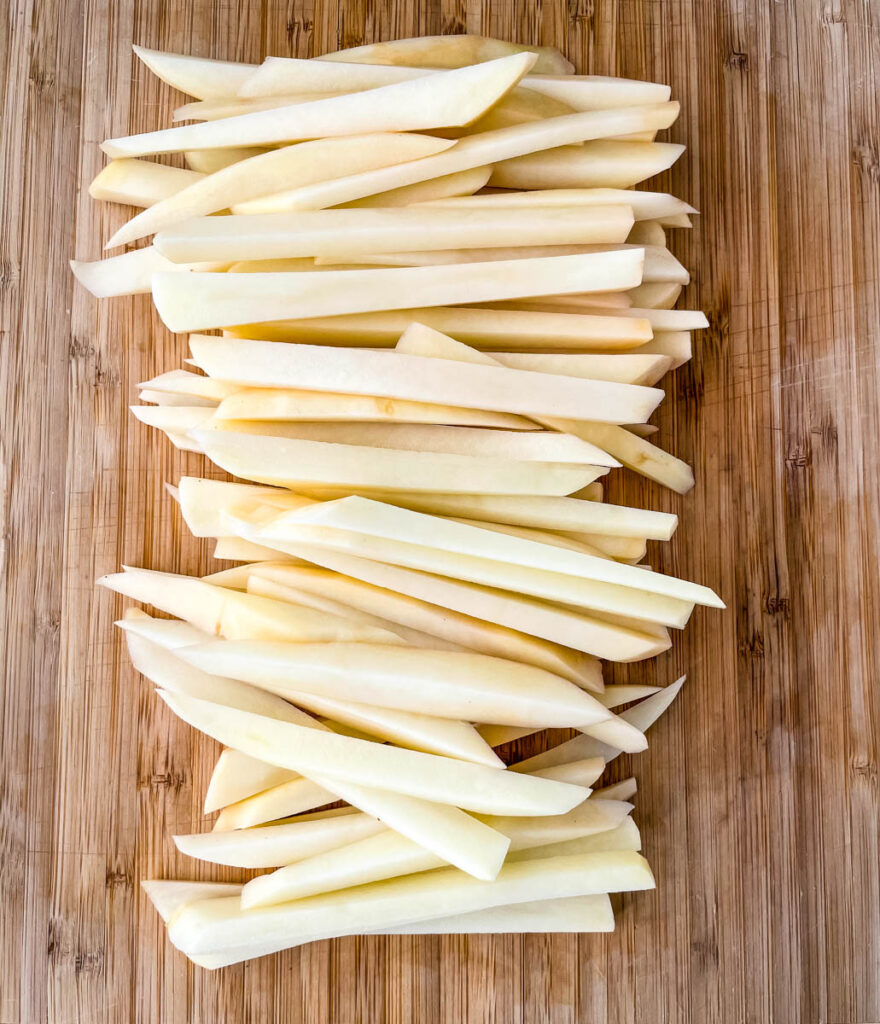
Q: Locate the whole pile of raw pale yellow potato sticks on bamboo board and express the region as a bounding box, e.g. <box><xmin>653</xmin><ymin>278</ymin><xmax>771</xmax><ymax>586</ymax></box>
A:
<box><xmin>73</xmin><ymin>36</ymin><xmax>723</xmax><ymax>968</ymax></box>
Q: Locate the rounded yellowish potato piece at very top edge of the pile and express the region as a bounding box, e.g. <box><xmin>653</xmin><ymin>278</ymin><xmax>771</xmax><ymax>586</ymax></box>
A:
<box><xmin>318</xmin><ymin>34</ymin><xmax>575</xmax><ymax>75</ymax></box>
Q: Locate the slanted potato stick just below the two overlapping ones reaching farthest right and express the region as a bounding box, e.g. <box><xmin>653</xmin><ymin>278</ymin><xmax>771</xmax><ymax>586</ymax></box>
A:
<box><xmin>233</xmin><ymin>545</ymin><xmax>669</xmax><ymax>662</ymax></box>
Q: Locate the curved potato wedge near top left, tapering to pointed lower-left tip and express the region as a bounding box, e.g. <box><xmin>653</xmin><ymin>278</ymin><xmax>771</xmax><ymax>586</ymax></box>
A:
<box><xmin>107</xmin><ymin>132</ymin><xmax>451</xmax><ymax>248</ymax></box>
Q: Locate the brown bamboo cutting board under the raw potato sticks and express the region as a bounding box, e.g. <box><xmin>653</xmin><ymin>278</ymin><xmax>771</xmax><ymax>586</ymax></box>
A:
<box><xmin>0</xmin><ymin>0</ymin><xmax>880</xmax><ymax>1024</ymax></box>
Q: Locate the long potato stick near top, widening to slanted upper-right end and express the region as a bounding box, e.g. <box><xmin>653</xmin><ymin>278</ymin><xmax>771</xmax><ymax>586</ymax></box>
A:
<box><xmin>101</xmin><ymin>54</ymin><xmax>534</xmax><ymax>157</ymax></box>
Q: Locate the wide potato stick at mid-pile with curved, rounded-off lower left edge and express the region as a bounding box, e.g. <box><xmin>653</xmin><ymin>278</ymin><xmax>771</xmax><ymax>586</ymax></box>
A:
<box><xmin>192</xmin><ymin>430</ymin><xmax>603</xmax><ymax>495</ymax></box>
